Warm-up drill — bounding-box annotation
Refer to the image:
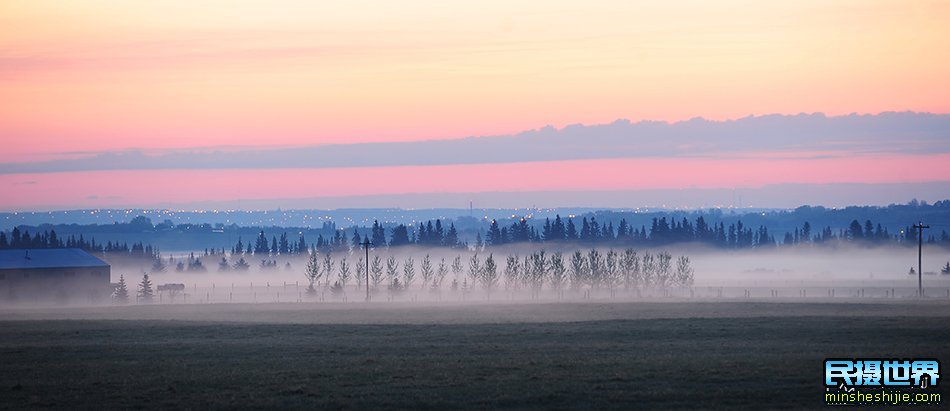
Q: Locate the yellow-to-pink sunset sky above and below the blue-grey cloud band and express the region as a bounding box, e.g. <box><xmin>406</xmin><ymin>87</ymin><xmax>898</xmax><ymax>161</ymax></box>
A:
<box><xmin>0</xmin><ymin>0</ymin><xmax>950</xmax><ymax>209</ymax></box>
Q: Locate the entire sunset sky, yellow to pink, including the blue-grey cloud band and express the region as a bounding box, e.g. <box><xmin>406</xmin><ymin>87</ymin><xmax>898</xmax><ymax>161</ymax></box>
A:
<box><xmin>0</xmin><ymin>0</ymin><xmax>950</xmax><ymax>210</ymax></box>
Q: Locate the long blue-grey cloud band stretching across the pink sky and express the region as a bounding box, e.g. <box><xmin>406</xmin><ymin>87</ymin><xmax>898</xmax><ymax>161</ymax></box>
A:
<box><xmin>0</xmin><ymin>112</ymin><xmax>950</xmax><ymax>174</ymax></box>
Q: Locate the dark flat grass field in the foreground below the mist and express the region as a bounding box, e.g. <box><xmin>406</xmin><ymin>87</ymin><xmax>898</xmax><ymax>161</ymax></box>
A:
<box><xmin>0</xmin><ymin>302</ymin><xmax>950</xmax><ymax>409</ymax></box>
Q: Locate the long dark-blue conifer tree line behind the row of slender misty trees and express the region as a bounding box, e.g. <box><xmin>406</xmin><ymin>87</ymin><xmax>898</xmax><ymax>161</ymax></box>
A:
<box><xmin>232</xmin><ymin>215</ymin><xmax>950</xmax><ymax>255</ymax></box>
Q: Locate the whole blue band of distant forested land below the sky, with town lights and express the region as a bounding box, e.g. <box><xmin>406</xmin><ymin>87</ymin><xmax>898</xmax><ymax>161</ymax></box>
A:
<box><xmin>0</xmin><ymin>200</ymin><xmax>950</xmax><ymax>259</ymax></box>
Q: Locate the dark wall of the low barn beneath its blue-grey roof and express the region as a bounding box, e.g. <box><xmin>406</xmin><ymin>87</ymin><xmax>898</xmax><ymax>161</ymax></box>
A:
<box><xmin>0</xmin><ymin>266</ymin><xmax>112</xmax><ymax>303</ymax></box>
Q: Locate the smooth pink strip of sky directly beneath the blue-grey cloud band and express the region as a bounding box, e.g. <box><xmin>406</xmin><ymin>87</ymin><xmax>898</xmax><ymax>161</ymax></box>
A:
<box><xmin>0</xmin><ymin>154</ymin><xmax>950</xmax><ymax>209</ymax></box>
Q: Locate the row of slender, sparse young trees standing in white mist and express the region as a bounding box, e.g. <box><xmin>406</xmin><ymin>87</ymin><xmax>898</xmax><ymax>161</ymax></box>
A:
<box><xmin>304</xmin><ymin>248</ymin><xmax>694</xmax><ymax>298</ymax></box>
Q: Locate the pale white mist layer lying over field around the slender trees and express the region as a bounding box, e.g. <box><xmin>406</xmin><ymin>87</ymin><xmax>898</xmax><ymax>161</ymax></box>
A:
<box><xmin>67</xmin><ymin>244</ymin><xmax>950</xmax><ymax>304</ymax></box>
